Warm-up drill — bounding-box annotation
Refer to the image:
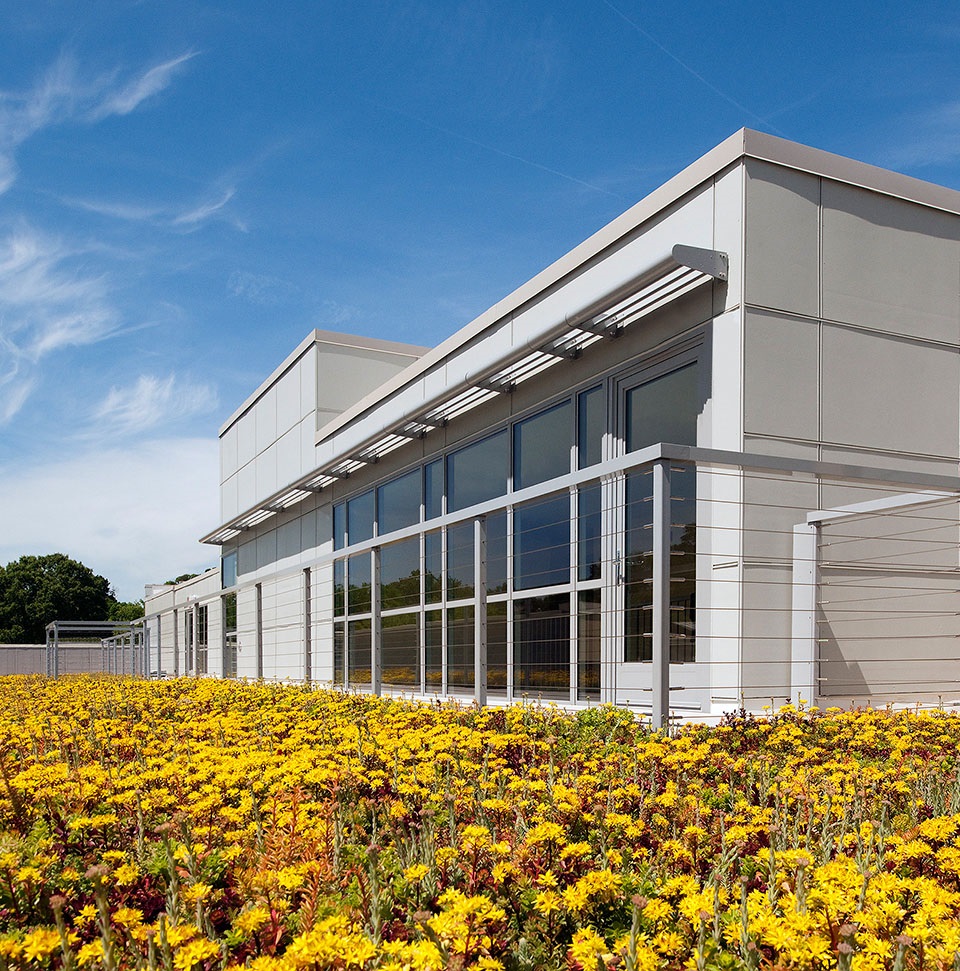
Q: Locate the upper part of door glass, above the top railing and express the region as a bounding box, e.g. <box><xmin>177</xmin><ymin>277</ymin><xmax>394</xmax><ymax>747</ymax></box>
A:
<box><xmin>626</xmin><ymin>364</ymin><xmax>700</xmax><ymax>452</ymax></box>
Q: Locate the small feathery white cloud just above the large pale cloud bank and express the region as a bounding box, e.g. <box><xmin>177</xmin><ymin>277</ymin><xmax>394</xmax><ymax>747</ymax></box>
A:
<box><xmin>91</xmin><ymin>374</ymin><xmax>218</xmax><ymax>436</ymax></box>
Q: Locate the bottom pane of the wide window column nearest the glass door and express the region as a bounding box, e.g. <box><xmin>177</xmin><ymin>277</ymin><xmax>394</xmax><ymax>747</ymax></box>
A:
<box><xmin>513</xmin><ymin>593</ymin><xmax>570</xmax><ymax>699</ymax></box>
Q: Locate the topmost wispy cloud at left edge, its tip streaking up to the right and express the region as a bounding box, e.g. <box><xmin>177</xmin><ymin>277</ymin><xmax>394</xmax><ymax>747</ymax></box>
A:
<box><xmin>0</xmin><ymin>51</ymin><xmax>198</xmax><ymax>194</ymax></box>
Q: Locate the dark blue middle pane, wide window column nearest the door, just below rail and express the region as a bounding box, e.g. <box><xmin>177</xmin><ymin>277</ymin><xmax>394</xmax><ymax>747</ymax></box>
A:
<box><xmin>513</xmin><ymin>493</ymin><xmax>570</xmax><ymax>590</ymax></box>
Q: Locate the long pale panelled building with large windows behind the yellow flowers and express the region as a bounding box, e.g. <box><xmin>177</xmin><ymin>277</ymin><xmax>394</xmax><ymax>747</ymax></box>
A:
<box><xmin>147</xmin><ymin>130</ymin><xmax>960</xmax><ymax>721</ymax></box>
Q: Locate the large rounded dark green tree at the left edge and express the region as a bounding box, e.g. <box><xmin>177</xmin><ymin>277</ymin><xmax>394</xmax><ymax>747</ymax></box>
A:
<box><xmin>0</xmin><ymin>553</ymin><xmax>116</xmax><ymax>644</ymax></box>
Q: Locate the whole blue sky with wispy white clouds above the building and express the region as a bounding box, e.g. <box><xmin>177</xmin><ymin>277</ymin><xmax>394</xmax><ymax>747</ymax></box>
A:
<box><xmin>0</xmin><ymin>0</ymin><xmax>960</xmax><ymax>599</ymax></box>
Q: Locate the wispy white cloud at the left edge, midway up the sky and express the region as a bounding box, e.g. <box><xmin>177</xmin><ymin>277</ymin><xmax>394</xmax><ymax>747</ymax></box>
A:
<box><xmin>0</xmin><ymin>226</ymin><xmax>121</xmax><ymax>422</ymax></box>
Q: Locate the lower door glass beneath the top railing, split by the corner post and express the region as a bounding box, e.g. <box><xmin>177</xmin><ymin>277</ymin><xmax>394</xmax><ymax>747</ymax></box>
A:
<box><xmin>624</xmin><ymin>466</ymin><xmax>697</xmax><ymax>664</ymax></box>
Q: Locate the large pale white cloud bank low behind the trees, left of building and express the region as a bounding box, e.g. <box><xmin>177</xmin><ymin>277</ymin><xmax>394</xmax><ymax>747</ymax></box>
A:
<box><xmin>0</xmin><ymin>438</ymin><xmax>219</xmax><ymax>600</ymax></box>
